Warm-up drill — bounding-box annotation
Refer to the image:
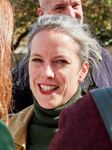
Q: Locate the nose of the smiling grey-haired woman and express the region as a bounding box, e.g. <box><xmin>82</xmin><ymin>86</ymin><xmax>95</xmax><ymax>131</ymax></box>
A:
<box><xmin>41</xmin><ymin>65</ymin><xmax>54</xmax><ymax>79</ymax></box>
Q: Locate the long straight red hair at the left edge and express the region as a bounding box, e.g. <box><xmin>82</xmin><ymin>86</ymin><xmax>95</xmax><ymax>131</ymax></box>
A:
<box><xmin>0</xmin><ymin>0</ymin><xmax>13</xmax><ymax>121</ymax></box>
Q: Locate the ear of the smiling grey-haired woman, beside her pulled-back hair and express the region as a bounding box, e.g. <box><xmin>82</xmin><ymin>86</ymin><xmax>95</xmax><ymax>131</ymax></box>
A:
<box><xmin>78</xmin><ymin>61</ymin><xmax>89</xmax><ymax>83</ymax></box>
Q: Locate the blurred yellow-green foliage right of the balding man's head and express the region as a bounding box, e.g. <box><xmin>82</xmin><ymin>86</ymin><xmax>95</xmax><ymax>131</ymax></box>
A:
<box><xmin>82</xmin><ymin>0</ymin><xmax>112</xmax><ymax>45</ymax></box>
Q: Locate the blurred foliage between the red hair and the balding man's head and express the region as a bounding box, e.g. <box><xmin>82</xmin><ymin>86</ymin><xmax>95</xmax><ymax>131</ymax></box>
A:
<box><xmin>11</xmin><ymin>0</ymin><xmax>39</xmax><ymax>49</ymax></box>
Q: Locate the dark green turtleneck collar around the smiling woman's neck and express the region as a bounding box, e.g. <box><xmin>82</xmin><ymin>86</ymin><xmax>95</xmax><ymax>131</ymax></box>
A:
<box><xmin>33</xmin><ymin>86</ymin><xmax>81</xmax><ymax>127</ymax></box>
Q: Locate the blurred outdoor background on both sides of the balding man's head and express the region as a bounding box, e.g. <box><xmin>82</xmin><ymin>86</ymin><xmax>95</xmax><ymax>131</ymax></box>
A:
<box><xmin>11</xmin><ymin>0</ymin><xmax>112</xmax><ymax>67</ymax></box>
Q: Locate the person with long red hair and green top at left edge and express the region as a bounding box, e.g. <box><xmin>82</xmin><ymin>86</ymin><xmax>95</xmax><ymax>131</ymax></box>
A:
<box><xmin>0</xmin><ymin>0</ymin><xmax>15</xmax><ymax>150</ymax></box>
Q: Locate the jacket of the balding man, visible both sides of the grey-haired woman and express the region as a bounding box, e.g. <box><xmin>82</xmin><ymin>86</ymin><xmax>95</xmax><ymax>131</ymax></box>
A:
<box><xmin>12</xmin><ymin>48</ymin><xmax>112</xmax><ymax>113</ymax></box>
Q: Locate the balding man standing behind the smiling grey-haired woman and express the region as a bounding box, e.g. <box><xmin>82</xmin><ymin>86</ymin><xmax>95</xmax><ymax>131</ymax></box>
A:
<box><xmin>12</xmin><ymin>0</ymin><xmax>112</xmax><ymax>113</ymax></box>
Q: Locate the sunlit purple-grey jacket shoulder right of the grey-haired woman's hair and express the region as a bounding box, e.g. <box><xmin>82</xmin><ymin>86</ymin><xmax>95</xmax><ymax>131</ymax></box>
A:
<box><xmin>92</xmin><ymin>48</ymin><xmax>112</xmax><ymax>88</ymax></box>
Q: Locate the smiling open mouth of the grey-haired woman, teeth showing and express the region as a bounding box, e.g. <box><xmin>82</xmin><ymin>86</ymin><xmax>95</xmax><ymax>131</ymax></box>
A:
<box><xmin>39</xmin><ymin>84</ymin><xmax>59</xmax><ymax>92</ymax></box>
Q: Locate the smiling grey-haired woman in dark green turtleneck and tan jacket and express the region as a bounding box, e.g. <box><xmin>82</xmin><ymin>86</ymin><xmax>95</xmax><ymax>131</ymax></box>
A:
<box><xmin>10</xmin><ymin>15</ymin><xmax>99</xmax><ymax>150</ymax></box>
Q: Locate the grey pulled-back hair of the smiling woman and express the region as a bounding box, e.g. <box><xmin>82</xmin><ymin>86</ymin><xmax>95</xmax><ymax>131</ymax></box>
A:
<box><xmin>15</xmin><ymin>15</ymin><xmax>100</xmax><ymax>91</ymax></box>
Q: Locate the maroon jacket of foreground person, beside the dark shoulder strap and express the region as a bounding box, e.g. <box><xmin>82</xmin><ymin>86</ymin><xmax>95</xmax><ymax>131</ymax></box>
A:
<box><xmin>49</xmin><ymin>95</ymin><xmax>112</xmax><ymax>150</ymax></box>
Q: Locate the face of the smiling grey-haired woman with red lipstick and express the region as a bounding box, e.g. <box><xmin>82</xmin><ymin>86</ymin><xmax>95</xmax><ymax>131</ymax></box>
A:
<box><xmin>29</xmin><ymin>30</ymin><xmax>87</xmax><ymax>109</ymax></box>
